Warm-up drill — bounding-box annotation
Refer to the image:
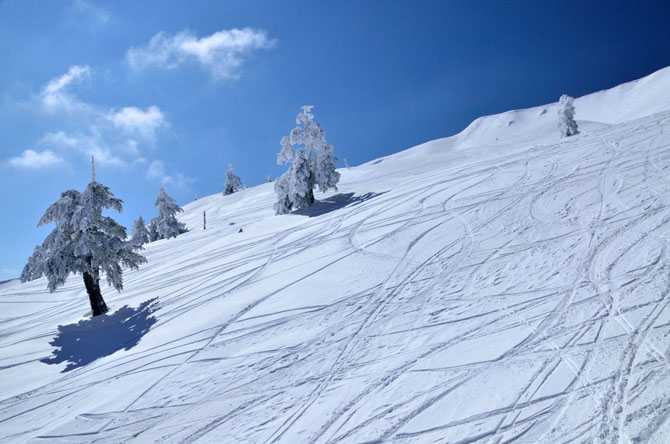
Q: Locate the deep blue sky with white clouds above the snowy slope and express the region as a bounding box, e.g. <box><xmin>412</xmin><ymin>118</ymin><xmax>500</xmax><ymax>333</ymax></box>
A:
<box><xmin>0</xmin><ymin>0</ymin><xmax>670</xmax><ymax>280</ymax></box>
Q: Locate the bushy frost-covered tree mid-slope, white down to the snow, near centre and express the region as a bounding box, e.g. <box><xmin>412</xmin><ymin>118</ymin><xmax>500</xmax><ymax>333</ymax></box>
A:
<box><xmin>274</xmin><ymin>106</ymin><xmax>340</xmax><ymax>214</ymax></box>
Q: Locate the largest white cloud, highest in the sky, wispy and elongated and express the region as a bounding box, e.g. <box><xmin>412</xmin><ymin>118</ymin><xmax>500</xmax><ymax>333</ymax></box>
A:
<box><xmin>126</xmin><ymin>28</ymin><xmax>277</xmax><ymax>80</ymax></box>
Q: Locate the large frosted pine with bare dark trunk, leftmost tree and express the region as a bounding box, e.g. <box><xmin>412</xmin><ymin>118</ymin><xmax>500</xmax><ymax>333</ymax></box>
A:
<box><xmin>21</xmin><ymin>161</ymin><xmax>147</xmax><ymax>316</ymax></box>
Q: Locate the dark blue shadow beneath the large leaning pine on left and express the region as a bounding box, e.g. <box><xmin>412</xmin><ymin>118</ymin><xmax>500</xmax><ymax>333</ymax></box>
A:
<box><xmin>41</xmin><ymin>298</ymin><xmax>158</xmax><ymax>373</ymax></box>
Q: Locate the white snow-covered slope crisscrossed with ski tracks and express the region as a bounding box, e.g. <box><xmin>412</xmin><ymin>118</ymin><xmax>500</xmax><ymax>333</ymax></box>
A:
<box><xmin>0</xmin><ymin>69</ymin><xmax>670</xmax><ymax>443</ymax></box>
